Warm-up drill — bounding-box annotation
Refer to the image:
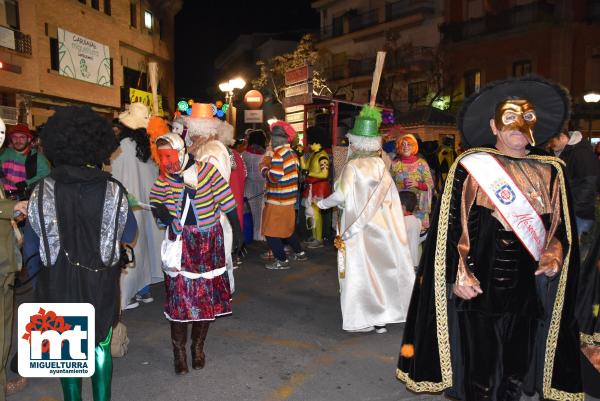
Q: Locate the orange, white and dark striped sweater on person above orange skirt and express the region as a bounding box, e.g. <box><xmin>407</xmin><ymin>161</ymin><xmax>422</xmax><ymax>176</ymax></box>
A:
<box><xmin>263</xmin><ymin>145</ymin><xmax>298</xmax><ymax>205</ymax></box>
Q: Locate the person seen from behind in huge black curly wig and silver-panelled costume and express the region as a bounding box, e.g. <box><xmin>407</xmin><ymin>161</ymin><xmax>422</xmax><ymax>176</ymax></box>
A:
<box><xmin>23</xmin><ymin>106</ymin><xmax>137</xmax><ymax>401</ymax></box>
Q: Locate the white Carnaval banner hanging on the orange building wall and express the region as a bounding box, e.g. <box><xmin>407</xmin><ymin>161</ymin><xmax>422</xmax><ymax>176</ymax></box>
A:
<box><xmin>58</xmin><ymin>28</ymin><xmax>111</xmax><ymax>86</ymax></box>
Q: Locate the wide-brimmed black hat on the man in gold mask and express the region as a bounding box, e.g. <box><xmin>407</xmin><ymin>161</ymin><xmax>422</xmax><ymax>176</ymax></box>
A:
<box><xmin>458</xmin><ymin>75</ymin><xmax>571</xmax><ymax>148</ymax></box>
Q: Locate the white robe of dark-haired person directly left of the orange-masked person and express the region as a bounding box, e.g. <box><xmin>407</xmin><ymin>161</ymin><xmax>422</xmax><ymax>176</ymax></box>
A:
<box><xmin>110</xmin><ymin>138</ymin><xmax>164</xmax><ymax>309</ymax></box>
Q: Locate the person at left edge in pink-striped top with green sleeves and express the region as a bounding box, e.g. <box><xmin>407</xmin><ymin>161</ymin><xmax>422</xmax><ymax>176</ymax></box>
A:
<box><xmin>0</xmin><ymin>124</ymin><xmax>50</xmax><ymax>200</ymax></box>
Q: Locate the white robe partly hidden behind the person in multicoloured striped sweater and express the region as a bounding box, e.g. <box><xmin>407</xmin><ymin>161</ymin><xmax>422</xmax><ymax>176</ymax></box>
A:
<box><xmin>194</xmin><ymin>140</ymin><xmax>235</xmax><ymax>293</ymax></box>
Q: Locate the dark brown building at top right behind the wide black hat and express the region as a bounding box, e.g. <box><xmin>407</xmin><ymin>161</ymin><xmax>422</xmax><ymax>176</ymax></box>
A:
<box><xmin>440</xmin><ymin>0</ymin><xmax>600</xmax><ymax>136</ymax></box>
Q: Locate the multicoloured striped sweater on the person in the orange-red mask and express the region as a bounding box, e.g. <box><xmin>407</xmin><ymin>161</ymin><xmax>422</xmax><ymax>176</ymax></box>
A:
<box><xmin>150</xmin><ymin>162</ymin><xmax>235</xmax><ymax>234</ymax></box>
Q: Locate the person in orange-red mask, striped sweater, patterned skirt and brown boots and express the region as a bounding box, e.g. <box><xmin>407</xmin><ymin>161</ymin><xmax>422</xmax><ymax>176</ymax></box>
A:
<box><xmin>150</xmin><ymin>133</ymin><xmax>242</xmax><ymax>375</ymax></box>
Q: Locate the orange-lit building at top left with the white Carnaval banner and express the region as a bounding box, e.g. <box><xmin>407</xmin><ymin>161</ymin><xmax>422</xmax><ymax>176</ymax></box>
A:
<box><xmin>0</xmin><ymin>0</ymin><xmax>181</xmax><ymax>127</ymax></box>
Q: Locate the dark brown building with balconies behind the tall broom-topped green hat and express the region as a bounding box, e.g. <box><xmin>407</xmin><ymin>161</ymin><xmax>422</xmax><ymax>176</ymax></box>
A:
<box><xmin>312</xmin><ymin>0</ymin><xmax>443</xmax><ymax>111</ymax></box>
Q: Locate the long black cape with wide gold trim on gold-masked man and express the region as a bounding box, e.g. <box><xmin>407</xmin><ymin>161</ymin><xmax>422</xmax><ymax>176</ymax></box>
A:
<box><xmin>396</xmin><ymin>147</ymin><xmax>584</xmax><ymax>400</ymax></box>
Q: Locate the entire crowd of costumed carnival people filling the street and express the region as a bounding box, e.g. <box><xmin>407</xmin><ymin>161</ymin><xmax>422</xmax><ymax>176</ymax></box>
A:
<box><xmin>0</xmin><ymin>73</ymin><xmax>600</xmax><ymax>401</ymax></box>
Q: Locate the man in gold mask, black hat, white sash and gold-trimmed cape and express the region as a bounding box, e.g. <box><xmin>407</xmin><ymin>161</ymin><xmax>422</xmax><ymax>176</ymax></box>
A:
<box><xmin>396</xmin><ymin>76</ymin><xmax>584</xmax><ymax>401</ymax></box>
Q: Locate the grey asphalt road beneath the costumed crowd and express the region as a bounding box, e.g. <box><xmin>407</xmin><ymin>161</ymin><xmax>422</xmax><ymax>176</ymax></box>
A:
<box><xmin>8</xmin><ymin>245</ymin><xmax>600</xmax><ymax>401</ymax></box>
